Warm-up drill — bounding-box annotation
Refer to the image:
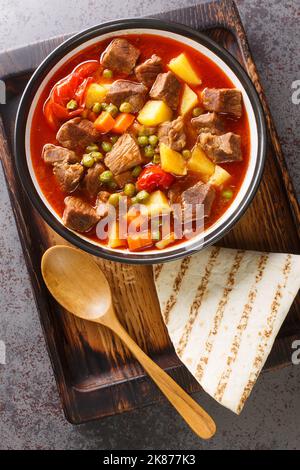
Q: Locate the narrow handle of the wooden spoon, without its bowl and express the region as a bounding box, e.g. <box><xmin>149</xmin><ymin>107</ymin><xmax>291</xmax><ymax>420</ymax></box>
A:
<box><xmin>106</xmin><ymin>315</ymin><xmax>216</xmax><ymax>439</ymax></box>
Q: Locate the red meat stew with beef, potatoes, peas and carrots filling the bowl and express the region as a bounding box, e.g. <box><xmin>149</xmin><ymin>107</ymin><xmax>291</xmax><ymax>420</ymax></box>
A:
<box><xmin>31</xmin><ymin>34</ymin><xmax>250</xmax><ymax>251</ymax></box>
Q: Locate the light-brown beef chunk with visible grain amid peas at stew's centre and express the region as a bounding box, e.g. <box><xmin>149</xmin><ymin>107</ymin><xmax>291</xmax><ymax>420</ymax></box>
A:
<box><xmin>104</xmin><ymin>134</ymin><xmax>143</xmax><ymax>175</ymax></box>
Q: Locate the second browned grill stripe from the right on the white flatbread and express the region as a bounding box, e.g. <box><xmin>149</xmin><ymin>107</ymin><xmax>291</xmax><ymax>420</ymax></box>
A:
<box><xmin>214</xmin><ymin>253</ymin><xmax>269</xmax><ymax>401</ymax></box>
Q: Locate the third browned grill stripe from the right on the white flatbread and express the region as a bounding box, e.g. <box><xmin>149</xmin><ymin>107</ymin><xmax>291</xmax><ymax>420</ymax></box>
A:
<box><xmin>195</xmin><ymin>250</ymin><xmax>245</xmax><ymax>381</ymax></box>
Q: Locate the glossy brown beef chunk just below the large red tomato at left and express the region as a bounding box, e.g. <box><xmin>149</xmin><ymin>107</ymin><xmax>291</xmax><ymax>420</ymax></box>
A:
<box><xmin>56</xmin><ymin>117</ymin><xmax>100</xmax><ymax>150</ymax></box>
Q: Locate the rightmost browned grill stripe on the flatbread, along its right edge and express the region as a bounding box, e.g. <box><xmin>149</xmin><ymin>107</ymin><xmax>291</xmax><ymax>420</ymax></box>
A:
<box><xmin>237</xmin><ymin>254</ymin><xmax>292</xmax><ymax>413</ymax></box>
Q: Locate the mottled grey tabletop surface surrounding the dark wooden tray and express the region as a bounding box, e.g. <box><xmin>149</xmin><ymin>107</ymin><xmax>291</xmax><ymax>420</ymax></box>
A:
<box><xmin>0</xmin><ymin>0</ymin><xmax>300</xmax><ymax>450</ymax></box>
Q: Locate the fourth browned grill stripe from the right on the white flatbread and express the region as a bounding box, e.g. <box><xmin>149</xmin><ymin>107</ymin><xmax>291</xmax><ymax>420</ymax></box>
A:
<box><xmin>176</xmin><ymin>247</ymin><xmax>220</xmax><ymax>357</ymax></box>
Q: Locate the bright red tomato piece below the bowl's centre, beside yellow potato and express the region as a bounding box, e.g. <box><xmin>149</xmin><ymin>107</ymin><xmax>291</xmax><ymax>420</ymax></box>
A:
<box><xmin>137</xmin><ymin>165</ymin><xmax>175</xmax><ymax>192</ymax></box>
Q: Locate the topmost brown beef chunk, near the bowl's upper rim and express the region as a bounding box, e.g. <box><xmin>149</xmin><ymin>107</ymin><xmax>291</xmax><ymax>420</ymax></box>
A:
<box><xmin>100</xmin><ymin>38</ymin><xmax>140</xmax><ymax>75</ymax></box>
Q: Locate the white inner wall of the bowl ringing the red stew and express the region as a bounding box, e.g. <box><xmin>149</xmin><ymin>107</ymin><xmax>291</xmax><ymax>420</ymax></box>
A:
<box><xmin>25</xmin><ymin>28</ymin><xmax>258</xmax><ymax>258</ymax></box>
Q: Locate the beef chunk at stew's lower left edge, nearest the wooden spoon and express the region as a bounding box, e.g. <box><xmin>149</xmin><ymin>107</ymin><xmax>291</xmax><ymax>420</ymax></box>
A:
<box><xmin>62</xmin><ymin>196</ymin><xmax>99</xmax><ymax>232</ymax></box>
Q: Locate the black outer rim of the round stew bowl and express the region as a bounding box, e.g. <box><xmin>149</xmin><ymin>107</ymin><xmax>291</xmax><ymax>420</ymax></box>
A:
<box><xmin>14</xmin><ymin>18</ymin><xmax>267</xmax><ymax>264</ymax></box>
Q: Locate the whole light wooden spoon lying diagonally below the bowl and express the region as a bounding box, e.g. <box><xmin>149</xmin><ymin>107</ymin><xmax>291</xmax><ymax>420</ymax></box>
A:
<box><xmin>42</xmin><ymin>245</ymin><xmax>216</xmax><ymax>439</ymax></box>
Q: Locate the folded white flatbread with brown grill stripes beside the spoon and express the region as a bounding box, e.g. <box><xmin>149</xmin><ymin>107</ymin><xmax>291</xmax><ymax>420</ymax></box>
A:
<box><xmin>154</xmin><ymin>247</ymin><xmax>300</xmax><ymax>413</ymax></box>
